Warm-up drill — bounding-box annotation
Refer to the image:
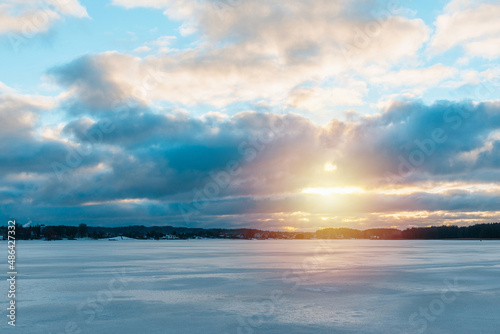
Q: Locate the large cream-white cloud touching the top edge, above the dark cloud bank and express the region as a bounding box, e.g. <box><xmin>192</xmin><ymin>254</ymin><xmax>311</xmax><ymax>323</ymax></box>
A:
<box><xmin>100</xmin><ymin>0</ymin><xmax>430</xmax><ymax>108</ymax></box>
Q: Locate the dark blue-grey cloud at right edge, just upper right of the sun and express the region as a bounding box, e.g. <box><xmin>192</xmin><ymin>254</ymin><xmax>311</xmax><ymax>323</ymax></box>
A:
<box><xmin>331</xmin><ymin>101</ymin><xmax>500</xmax><ymax>182</ymax></box>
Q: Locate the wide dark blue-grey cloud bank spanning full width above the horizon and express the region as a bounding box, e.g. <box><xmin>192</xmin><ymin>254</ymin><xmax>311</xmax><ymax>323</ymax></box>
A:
<box><xmin>0</xmin><ymin>92</ymin><xmax>500</xmax><ymax>227</ymax></box>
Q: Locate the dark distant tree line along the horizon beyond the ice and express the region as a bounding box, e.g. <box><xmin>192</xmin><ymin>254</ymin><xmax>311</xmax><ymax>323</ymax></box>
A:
<box><xmin>0</xmin><ymin>223</ymin><xmax>500</xmax><ymax>240</ymax></box>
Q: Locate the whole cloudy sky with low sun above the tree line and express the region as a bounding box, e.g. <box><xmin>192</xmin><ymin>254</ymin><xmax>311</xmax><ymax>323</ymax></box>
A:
<box><xmin>0</xmin><ymin>0</ymin><xmax>500</xmax><ymax>231</ymax></box>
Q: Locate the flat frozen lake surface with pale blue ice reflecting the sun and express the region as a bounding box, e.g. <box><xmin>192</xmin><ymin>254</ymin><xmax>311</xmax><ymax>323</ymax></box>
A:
<box><xmin>0</xmin><ymin>240</ymin><xmax>500</xmax><ymax>334</ymax></box>
